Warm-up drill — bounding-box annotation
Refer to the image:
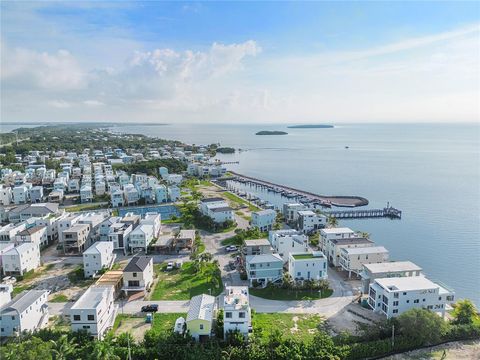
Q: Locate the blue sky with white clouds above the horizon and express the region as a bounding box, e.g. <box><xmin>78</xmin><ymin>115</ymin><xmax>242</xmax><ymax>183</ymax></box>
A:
<box><xmin>0</xmin><ymin>1</ymin><xmax>480</xmax><ymax>123</ymax></box>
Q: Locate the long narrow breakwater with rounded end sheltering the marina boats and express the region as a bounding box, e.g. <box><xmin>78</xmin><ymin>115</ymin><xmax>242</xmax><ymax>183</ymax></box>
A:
<box><xmin>223</xmin><ymin>171</ymin><xmax>368</xmax><ymax>207</ymax></box>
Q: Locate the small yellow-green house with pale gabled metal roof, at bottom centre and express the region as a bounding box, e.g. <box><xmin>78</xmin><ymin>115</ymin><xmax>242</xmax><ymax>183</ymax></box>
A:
<box><xmin>186</xmin><ymin>294</ymin><xmax>215</xmax><ymax>341</ymax></box>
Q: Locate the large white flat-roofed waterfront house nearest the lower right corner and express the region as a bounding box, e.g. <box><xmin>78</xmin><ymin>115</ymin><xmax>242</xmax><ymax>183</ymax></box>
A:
<box><xmin>368</xmin><ymin>276</ymin><xmax>455</xmax><ymax>318</ymax></box>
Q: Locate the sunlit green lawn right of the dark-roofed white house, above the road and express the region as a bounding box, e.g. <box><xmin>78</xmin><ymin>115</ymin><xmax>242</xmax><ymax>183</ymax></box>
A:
<box><xmin>151</xmin><ymin>262</ymin><xmax>223</xmax><ymax>300</ymax></box>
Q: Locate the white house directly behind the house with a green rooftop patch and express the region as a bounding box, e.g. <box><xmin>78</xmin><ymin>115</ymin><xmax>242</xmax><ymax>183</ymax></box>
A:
<box><xmin>268</xmin><ymin>229</ymin><xmax>308</xmax><ymax>263</ymax></box>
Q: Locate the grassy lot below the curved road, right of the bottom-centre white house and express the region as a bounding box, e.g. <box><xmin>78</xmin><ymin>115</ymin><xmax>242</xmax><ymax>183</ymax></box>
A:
<box><xmin>252</xmin><ymin>313</ymin><xmax>323</xmax><ymax>340</ymax></box>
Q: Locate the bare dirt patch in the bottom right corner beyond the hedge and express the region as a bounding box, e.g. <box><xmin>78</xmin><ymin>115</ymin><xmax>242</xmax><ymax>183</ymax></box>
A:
<box><xmin>384</xmin><ymin>340</ymin><xmax>480</xmax><ymax>360</ymax></box>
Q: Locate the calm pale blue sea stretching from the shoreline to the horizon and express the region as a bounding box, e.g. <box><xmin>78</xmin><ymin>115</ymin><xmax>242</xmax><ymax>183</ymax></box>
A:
<box><xmin>3</xmin><ymin>124</ymin><xmax>480</xmax><ymax>305</ymax></box>
